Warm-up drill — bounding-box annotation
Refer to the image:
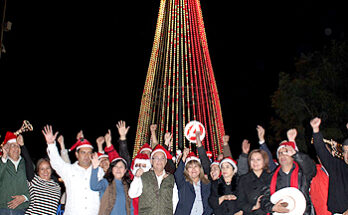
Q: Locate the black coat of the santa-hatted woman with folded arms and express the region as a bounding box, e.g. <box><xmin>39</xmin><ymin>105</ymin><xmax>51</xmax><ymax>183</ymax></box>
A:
<box><xmin>209</xmin><ymin>176</ymin><xmax>240</xmax><ymax>215</ymax></box>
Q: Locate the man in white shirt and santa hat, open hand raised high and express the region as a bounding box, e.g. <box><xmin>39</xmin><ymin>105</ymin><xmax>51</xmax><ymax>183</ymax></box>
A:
<box><xmin>42</xmin><ymin>125</ymin><xmax>104</xmax><ymax>215</ymax></box>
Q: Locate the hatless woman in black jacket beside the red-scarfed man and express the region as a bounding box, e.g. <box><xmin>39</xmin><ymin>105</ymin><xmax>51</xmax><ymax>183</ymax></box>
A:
<box><xmin>237</xmin><ymin>149</ymin><xmax>271</xmax><ymax>215</ymax></box>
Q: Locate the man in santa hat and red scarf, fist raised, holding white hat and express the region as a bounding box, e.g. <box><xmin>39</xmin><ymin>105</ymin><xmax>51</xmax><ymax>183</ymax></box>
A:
<box><xmin>261</xmin><ymin>129</ymin><xmax>316</xmax><ymax>215</ymax></box>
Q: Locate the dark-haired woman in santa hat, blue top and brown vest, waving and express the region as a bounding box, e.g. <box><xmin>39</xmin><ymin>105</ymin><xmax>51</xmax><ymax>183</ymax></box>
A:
<box><xmin>90</xmin><ymin>153</ymin><xmax>133</xmax><ymax>215</ymax></box>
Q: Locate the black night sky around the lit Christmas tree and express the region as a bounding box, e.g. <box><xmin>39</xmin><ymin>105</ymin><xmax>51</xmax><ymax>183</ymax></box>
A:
<box><xmin>0</xmin><ymin>0</ymin><xmax>348</xmax><ymax>159</ymax></box>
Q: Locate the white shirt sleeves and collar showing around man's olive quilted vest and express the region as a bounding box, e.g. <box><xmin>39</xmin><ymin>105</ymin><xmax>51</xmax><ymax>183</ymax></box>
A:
<box><xmin>128</xmin><ymin>170</ymin><xmax>179</xmax><ymax>214</ymax></box>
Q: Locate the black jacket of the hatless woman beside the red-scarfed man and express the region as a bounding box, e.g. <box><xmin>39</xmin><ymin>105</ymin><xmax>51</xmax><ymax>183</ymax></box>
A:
<box><xmin>237</xmin><ymin>171</ymin><xmax>272</xmax><ymax>215</ymax></box>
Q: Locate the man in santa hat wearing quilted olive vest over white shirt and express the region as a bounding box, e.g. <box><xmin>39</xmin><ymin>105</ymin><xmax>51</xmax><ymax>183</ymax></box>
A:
<box><xmin>128</xmin><ymin>145</ymin><xmax>178</xmax><ymax>215</ymax></box>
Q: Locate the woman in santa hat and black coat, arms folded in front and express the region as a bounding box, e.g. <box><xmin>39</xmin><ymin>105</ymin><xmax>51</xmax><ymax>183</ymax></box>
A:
<box><xmin>209</xmin><ymin>157</ymin><xmax>242</xmax><ymax>215</ymax></box>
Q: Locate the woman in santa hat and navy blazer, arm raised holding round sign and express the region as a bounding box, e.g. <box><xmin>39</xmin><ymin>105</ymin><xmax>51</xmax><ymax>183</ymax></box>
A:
<box><xmin>174</xmin><ymin>148</ymin><xmax>213</xmax><ymax>215</ymax></box>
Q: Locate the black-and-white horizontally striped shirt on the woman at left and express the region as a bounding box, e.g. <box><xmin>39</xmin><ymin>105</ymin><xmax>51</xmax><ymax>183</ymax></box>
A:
<box><xmin>25</xmin><ymin>175</ymin><xmax>60</xmax><ymax>215</ymax></box>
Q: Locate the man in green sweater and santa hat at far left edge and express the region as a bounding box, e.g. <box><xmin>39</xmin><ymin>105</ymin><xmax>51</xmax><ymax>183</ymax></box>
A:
<box><xmin>0</xmin><ymin>132</ymin><xmax>29</xmax><ymax>215</ymax></box>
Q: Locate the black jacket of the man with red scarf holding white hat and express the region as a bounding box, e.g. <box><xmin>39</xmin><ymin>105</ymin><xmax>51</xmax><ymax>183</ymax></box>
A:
<box><xmin>261</xmin><ymin>152</ymin><xmax>317</xmax><ymax>215</ymax></box>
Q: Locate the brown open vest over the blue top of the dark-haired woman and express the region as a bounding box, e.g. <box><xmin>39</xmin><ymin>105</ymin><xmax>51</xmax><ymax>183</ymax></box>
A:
<box><xmin>98</xmin><ymin>180</ymin><xmax>131</xmax><ymax>215</ymax></box>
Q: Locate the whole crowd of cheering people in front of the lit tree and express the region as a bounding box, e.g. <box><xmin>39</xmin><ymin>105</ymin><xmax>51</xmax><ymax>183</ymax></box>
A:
<box><xmin>0</xmin><ymin>118</ymin><xmax>348</xmax><ymax>215</ymax></box>
